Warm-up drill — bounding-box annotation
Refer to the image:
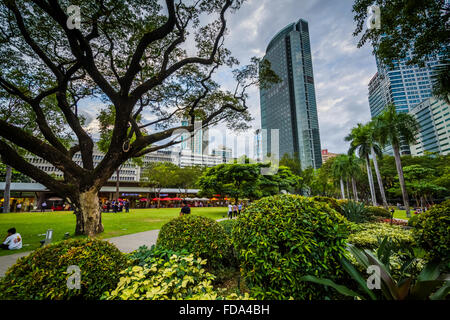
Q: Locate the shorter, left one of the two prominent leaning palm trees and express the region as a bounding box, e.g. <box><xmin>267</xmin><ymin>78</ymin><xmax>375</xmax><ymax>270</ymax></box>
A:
<box><xmin>345</xmin><ymin>123</ymin><xmax>377</xmax><ymax>206</ymax></box>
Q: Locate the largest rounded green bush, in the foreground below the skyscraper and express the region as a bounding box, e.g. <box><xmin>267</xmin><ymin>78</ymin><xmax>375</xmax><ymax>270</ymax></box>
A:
<box><xmin>232</xmin><ymin>195</ymin><xmax>347</xmax><ymax>299</ymax></box>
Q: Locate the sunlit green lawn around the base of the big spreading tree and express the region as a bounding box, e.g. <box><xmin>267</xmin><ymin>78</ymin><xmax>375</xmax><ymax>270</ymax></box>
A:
<box><xmin>0</xmin><ymin>207</ymin><xmax>227</xmax><ymax>256</ymax></box>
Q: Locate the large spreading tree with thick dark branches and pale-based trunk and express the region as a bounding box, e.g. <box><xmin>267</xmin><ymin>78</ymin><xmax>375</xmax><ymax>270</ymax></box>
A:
<box><xmin>0</xmin><ymin>0</ymin><xmax>277</xmax><ymax>236</ymax></box>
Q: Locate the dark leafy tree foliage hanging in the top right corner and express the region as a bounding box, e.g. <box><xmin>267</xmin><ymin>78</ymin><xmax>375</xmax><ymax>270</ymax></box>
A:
<box><xmin>353</xmin><ymin>0</ymin><xmax>450</xmax><ymax>101</ymax></box>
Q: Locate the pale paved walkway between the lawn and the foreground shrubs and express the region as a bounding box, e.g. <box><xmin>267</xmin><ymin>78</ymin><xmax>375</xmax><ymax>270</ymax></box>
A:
<box><xmin>0</xmin><ymin>219</ymin><xmax>232</xmax><ymax>277</ymax></box>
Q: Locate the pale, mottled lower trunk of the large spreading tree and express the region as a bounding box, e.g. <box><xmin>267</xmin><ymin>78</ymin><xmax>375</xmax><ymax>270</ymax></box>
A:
<box><xmin>75</xmin><ymin>187</ymin><xmax>103</xmax><ymax>237</ymax></box>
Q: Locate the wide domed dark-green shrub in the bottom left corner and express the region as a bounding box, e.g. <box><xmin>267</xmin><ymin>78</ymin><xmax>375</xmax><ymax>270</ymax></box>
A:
<box><xmin>0</xmin><ymin>239</ymin><xmax>127</xmax><ymax>300</ymax></box>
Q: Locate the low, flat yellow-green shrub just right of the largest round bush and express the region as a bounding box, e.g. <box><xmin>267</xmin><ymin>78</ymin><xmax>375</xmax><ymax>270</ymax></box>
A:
<box><xmin>348</xmin><ymin>223</ymin><xmax>415</xmax><ymax>249</ymax></box>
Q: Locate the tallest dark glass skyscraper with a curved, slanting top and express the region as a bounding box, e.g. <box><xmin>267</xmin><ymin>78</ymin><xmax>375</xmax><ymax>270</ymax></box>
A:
<box><xmin>260</xmin><ymin>19</ymin><xmax>322</xmax><ymax>169</ymax></box>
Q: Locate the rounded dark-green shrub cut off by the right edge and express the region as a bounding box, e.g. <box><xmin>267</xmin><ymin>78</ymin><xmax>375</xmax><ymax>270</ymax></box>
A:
<box><xmin>413</xmin><ymin>200</ymin><xmax>450</xmax><ymax>259</ymax></box>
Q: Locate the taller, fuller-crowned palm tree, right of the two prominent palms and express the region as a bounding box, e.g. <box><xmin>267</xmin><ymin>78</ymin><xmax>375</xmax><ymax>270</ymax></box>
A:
<box><xmin>374</xmin><ymin>104</ymin><xmax>419</xmax><ymax>217</ymax></box>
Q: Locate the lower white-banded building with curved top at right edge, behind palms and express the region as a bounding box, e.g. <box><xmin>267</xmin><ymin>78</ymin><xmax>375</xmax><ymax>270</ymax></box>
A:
<box><xmin>409</xmin><ymin>98</ymin><xmax>450</xmax><ymax>156</ymax></box>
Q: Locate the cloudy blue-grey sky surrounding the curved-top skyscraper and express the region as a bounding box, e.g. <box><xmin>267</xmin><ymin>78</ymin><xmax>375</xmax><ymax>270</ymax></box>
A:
<box><xmin>82</xmin><ymin>0</ymin><xmax>376</xmax><ymax>156</ymax></box>
